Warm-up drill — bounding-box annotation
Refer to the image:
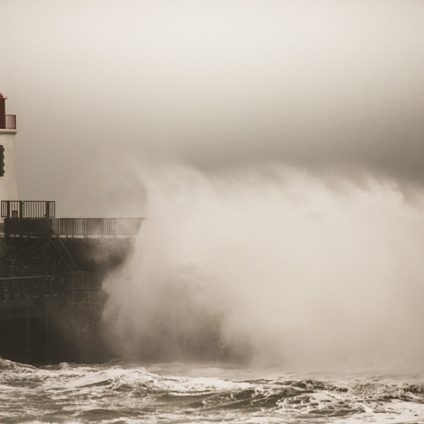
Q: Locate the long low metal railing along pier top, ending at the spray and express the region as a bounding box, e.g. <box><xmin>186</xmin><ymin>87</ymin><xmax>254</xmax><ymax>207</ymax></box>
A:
<box><xmin>4</xmin><ymin>218</ymin><xmax>143</xmax><ymax>238</ymax></box>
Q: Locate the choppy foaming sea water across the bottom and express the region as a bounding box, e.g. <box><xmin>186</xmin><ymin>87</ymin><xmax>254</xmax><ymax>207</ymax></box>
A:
<box><xmin>0</xmin><ymin>359</ymin><xmax>424</xmax><ymax>423</ymax></box>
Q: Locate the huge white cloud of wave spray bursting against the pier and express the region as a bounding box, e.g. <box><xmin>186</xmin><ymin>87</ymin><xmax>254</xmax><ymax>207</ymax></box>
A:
<box><xmin>105</xmin><ymin>166</ymin><xmax>424</xmax><ymax>371</ymax></box>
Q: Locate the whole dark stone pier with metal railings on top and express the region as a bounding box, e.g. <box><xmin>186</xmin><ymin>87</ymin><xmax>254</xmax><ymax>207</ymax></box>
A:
<box><xmin>0</xmin><ymin>200</ymin><xmax>143</xmax><ymax>364</ymax></box>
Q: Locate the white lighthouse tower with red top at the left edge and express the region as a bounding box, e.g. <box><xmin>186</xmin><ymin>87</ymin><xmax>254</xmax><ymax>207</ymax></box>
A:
<box><xmin>0</xmin><ymin>93</ymin><xmax>18</xmax><ymax>200</ymax></box>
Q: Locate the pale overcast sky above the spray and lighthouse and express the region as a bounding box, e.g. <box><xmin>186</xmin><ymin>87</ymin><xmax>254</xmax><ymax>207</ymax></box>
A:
<box><xmin>0</xmin><ymin>0</ymin><xmax>424</xmax><ymax>212</ymax></box>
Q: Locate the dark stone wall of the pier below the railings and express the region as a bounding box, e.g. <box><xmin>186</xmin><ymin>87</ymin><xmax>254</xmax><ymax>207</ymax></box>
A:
<box><xmin>0</xmin><ymin>238</ymin><xmax>132</xmax><ymax>364</ymax></box>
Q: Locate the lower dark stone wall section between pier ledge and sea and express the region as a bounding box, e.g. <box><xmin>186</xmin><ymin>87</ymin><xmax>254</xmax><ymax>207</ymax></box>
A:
<box><xmin>0</xmin><ymin>302</ymin><xmax>110</xmax><ymax>365</ymax></box>
